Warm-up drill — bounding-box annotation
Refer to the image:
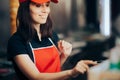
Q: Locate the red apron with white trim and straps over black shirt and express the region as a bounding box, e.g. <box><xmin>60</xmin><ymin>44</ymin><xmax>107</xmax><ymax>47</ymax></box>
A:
<box><xmin>31</xmin><ymin>38</ymin><xmax>61</xmax><ymax>73</ymax></box>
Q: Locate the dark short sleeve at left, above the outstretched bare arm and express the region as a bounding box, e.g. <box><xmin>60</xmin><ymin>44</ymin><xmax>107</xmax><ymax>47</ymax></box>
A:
<box><xmin>7</xmin><ymin>36</ymin><xmax>27</xmax><ymax>60</ymax></box>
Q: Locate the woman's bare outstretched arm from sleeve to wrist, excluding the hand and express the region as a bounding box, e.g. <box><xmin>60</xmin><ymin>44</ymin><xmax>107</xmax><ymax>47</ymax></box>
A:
<box><xmin>14</xmin><ymin>55</ymin><xmax>71</xmax><ymax>80</ymax></box>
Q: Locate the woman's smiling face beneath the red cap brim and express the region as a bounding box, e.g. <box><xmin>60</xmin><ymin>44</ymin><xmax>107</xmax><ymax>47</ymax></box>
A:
<box><xmin>30</xmin><ymin>2</ymin><xmax>50</xmax><ymax>24</ymax></box>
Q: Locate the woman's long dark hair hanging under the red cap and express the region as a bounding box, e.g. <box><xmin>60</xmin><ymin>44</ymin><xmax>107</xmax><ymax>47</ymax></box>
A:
<box><xmin>16</xmin><ymin>1</ymin><xmax>52</xmax><ymax>42</ymax></box>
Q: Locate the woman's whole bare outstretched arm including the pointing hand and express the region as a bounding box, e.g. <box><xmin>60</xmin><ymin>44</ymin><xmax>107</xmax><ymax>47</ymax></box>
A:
<box><xmin>14</xmin><ymin>54</ymin><xmax>96</xmax><ymax>80</ymax></box>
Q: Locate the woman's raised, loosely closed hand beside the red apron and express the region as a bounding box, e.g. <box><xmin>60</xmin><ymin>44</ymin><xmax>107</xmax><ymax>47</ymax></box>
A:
<box><xmin>58</xmin><ymin>40</ymin><xmax>72</xmax><ymax>57</ymax></box>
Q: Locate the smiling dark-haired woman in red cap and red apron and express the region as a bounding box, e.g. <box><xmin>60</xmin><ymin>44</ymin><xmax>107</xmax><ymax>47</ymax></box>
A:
<box><xmin>8</xmin><ymin>0</ymin><xmax>96</xmax><ymax>80</ymax></box>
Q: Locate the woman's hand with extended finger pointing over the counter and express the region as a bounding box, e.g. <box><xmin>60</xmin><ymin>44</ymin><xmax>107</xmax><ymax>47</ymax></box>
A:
<box><xmin>70</xmin><ymin>60</ymin><xmax>97</xmax><ymax>77</ymax></box>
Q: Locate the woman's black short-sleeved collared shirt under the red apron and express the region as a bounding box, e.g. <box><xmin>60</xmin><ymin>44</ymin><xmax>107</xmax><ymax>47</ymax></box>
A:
<box><xmin>7</xmin><ymin>32</ymin><xmax>59</xmax><ymax>80</ymax></box>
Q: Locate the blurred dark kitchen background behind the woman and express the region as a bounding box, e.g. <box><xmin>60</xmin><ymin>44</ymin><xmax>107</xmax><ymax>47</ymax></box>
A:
<box><xmin>0</xmin><ymin>0</ymin><xmax>120</xmax><ymax>80</ymax></box>
